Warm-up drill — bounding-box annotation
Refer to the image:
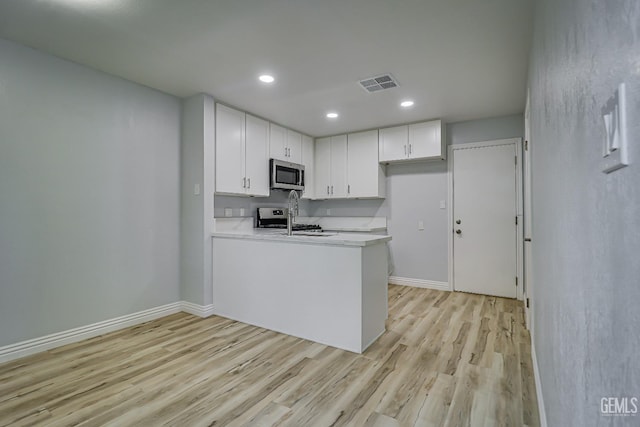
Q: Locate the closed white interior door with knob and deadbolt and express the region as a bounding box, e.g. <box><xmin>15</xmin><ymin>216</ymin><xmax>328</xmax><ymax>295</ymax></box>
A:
<box><xmin>453</xmin><ymin>141</ymin><xmax>517</xmax><ymax>298</ymax></box>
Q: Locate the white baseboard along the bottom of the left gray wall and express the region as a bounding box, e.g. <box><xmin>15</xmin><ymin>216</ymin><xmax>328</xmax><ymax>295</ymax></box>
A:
<box><xmin>0</xmin><ymin>301</ymin><xmax>218</xmax><ymax>363</ymax></box>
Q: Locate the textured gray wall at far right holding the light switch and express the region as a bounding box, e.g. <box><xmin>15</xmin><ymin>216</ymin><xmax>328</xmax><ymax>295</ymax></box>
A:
<box><xmin>530</xmin><ymin>0</ymin><xmax>640</xmax><ymax>426</ymax></box>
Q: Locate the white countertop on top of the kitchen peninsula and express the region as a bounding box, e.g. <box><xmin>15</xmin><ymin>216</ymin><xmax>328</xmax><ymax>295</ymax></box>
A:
<box><xmin>211</xmin><ymin>229</ymin><xmax>391</xmax><ymax>246</ymax></box>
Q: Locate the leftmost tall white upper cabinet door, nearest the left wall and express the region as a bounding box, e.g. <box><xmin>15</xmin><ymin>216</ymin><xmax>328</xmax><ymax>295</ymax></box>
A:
<box><xmin>216</xmin><ymin>104</ymin><xmax>245</xmax><ymax>194</ymax></box>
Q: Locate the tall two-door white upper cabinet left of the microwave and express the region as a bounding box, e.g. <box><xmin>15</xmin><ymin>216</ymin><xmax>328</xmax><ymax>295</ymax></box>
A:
<box><xmin>216</xmin><ymin>104</ymin><xmax>269</xmax><ymax>196</ymax></box>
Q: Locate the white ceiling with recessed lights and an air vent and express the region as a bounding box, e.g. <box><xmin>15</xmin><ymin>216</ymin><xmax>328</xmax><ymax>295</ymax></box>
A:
<box><xmin>0</xmin><ymin>0</ymin><xmax>533</xmax><ymax>136</ymax></box>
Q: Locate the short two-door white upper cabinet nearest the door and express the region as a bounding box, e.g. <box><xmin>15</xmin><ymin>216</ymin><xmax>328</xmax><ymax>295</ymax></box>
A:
<box><xmin>379</xmin><ymin>120</ymin><xmax>446</xmax><ymax>163</ymax></box>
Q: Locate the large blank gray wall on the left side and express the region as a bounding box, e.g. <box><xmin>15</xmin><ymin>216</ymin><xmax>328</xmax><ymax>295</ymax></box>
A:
<box><xmin>0</xmin><ymin>40</ymin><xmax>180</xmax><ymax>346</ymax></box>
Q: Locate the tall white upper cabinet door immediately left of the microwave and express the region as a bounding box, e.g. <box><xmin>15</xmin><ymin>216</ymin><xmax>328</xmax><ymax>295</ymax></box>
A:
<box><xmin>245</xmin><ymin>114</ymin><xmax>269</xmax><ymax>196</ymax></box>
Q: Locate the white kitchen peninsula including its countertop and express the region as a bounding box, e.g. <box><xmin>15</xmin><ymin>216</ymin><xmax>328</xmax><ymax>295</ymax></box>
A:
<box><xmin>212</xmin><ymin>229</ymin><xmax>391</xmax><ymax>353</ymax></box>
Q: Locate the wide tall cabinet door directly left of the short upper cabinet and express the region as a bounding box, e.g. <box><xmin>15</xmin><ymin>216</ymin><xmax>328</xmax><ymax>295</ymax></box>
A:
<box><xmin>347</xmin><ymin>130</ymin><xmax>382</xmax><ymax>197</ymax></box>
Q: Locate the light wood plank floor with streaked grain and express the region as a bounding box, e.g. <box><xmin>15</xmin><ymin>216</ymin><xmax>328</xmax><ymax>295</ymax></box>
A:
<box><xmin>0</xmin><ymin>286</ymin><xmax>539</xmax><ymax>427</ymax></box>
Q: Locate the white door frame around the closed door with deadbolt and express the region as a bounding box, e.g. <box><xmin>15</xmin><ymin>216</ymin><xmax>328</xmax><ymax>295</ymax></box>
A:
<box><xmin>447</xmin><ymin>138</ymin><xmax>524</xmax><ymax>300</ymax></box>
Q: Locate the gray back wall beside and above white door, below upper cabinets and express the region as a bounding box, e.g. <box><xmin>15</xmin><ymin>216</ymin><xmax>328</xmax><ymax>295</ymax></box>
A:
<box><xmin>310</xmin><ymin>114</ymin><xmax>524</xmax><ymax>282</ymax></box>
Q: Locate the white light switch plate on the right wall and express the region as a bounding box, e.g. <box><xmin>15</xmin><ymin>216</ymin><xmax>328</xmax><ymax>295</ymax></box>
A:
<box><xmin>601</xmin><ymin>83</ymin><xmax>629</xmax><ymax>173</ymax></box>
